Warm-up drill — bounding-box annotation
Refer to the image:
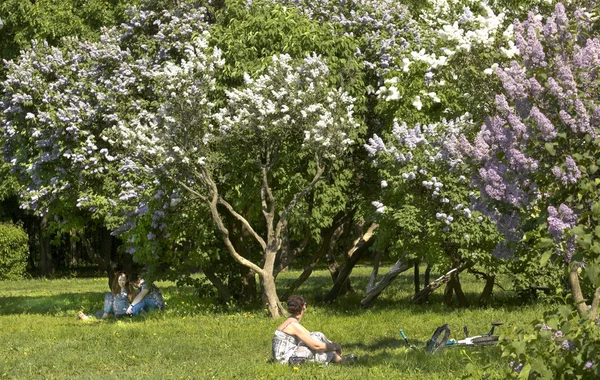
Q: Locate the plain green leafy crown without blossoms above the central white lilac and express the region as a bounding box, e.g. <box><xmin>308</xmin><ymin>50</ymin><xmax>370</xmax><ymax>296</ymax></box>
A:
<box><xmin>210</xmin><ymin>0</ymin><xmax>365</xmax><ymax>108</ymax></box>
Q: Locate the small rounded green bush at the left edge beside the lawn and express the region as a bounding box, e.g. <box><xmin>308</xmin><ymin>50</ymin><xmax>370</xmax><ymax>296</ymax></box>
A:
<box><xmin>0</xmin><ymin>223</ymin><xmax>29</xmax><ymax>280</ymax></box>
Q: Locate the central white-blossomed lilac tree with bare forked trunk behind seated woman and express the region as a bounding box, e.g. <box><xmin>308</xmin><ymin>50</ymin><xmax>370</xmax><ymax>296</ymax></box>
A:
<box><xmin>122</xmin><ymin>51</ymin><xmax>358</xmax><ymax>317</ymax></box>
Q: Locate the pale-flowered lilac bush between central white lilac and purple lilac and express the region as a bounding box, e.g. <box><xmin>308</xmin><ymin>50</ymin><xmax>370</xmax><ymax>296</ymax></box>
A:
<box><xmin>365</xmin><ymin>114</ymin><xmax>499</xmax><ymax>296</ymax></box>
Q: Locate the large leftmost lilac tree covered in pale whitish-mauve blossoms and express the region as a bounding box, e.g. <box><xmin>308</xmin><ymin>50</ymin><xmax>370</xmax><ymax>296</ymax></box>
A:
<box><xmin>1</xmin><ymin>2</ymin><xmax>216</xmax><ymax>280</ymax></box>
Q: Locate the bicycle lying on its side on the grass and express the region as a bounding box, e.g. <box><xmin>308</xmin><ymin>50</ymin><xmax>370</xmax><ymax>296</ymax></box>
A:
<box><xmin>399</xmin><ymin>322</ymin><xmax>504</xmax><ymax>354</ymax></box>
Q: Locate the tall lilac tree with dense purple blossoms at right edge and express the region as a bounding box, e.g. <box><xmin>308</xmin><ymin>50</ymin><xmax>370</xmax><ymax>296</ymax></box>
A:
<box><xmin>453</xmin><ymin>4</ymin><xmax>600</xmax><ymax>318</ymax></box>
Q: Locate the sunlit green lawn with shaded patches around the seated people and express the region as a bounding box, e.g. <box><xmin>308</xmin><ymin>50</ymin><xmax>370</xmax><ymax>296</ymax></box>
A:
<box><xmin>0</xmin><ymin>268</ymin><xmax>546</xmax><ymax>379</ymax></box>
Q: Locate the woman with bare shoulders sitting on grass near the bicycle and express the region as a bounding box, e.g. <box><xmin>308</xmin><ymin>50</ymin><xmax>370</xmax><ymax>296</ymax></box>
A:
<box><xmin>272</xmin><ymin>296</ymin><xmax>356</xmax><ymax>365</ymax></box>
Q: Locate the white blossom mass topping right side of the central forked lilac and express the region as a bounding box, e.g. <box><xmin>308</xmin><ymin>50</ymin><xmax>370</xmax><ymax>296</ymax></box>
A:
<box><xmin>215</xmin><ymin>54</ymin><xmax>358</xmax><ymax>156</ymax></box>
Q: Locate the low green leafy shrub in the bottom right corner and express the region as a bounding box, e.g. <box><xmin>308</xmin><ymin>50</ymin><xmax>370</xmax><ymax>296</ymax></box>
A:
<box><xmin>502</xmin><ymin>306</ymin><xmax>600</xmax><ymax>379</ymax></box>
